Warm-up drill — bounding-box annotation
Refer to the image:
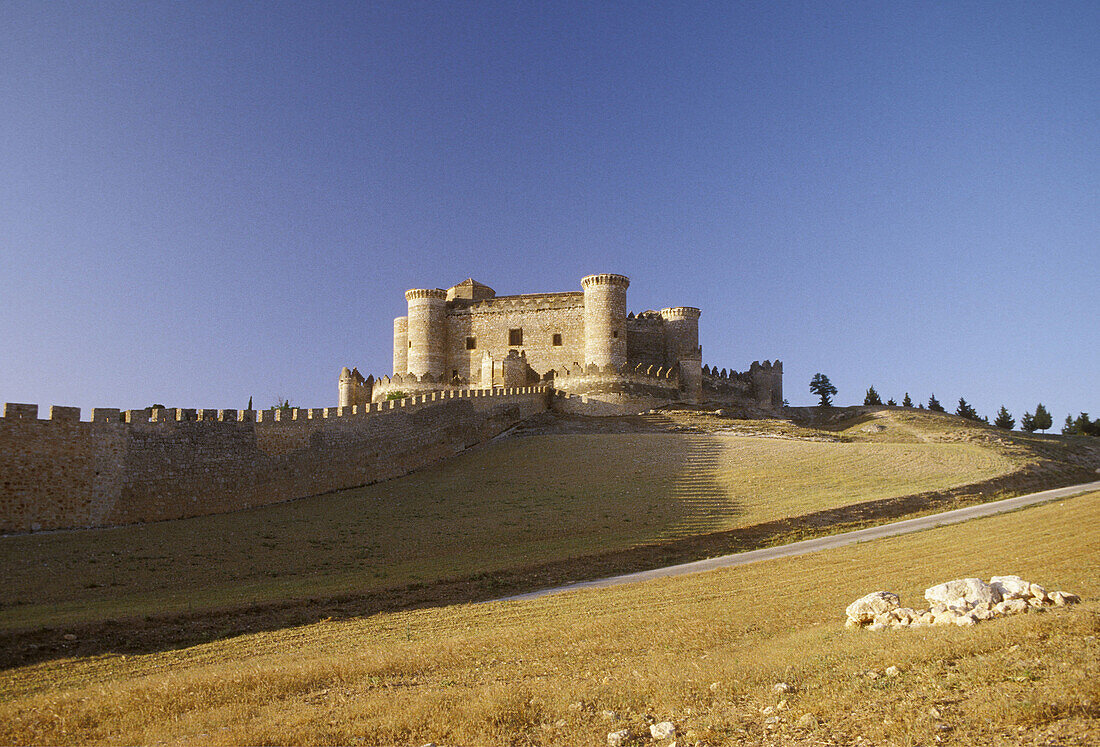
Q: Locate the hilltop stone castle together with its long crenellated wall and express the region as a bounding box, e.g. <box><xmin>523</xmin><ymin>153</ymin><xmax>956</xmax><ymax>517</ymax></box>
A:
<box><xmin>0</xmin><ymin>274</ymin><xmax>783</xmax><ymax>532</ymax></box>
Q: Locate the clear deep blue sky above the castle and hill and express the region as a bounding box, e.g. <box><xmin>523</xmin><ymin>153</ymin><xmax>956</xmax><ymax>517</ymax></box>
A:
<box><xmin>0</xmin><ymin>0</ymin><xmax>1100</xmax><ymax>427</ymax></box>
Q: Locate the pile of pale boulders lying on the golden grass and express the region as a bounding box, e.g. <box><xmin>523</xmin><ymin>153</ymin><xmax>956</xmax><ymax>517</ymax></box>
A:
<box><xmin>845</xmin><ymin>575</ymin><xmax>1081</xmax><ymax>630</ymax></box>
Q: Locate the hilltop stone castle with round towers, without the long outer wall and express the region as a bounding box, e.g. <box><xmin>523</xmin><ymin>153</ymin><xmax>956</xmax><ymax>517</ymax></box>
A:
<box><xmin>339</xmin><ymin>273</ymin><xmax>783</xmax><ymax>410</ymax></box>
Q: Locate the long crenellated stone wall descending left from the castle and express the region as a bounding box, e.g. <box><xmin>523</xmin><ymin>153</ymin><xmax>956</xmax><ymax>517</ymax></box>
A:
<box><xmin>0</xmin><ymin>385</ymin><xmax>550</xmax><ymax>534</ymax></box>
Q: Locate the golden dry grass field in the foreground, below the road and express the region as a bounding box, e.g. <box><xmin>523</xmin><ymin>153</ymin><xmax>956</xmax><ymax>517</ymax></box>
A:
<box><xmin>0</xmin><ymin>493</ymin><xmax>1100</xmax><ymax>745</ymax></box>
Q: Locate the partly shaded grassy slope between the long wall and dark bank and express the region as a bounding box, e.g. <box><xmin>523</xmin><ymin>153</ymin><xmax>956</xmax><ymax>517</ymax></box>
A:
<box><xmin>0</xmin><ymin>420</ymin><xmax>1026</xmax><ymax>629</ymax></box>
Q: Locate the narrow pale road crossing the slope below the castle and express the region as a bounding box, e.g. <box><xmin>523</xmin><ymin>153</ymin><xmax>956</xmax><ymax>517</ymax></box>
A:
<box><xmin>493</xmin><ymin>481</ymin><xmax>1100</xmax><ymax>602</ymax></box>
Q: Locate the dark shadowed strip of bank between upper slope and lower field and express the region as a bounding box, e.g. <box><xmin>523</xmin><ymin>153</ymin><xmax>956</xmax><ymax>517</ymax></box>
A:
<box><xmin>0</xmin><ymin>455</ymin><xmax>1096</xmax><ymax>669</ymax></box>
